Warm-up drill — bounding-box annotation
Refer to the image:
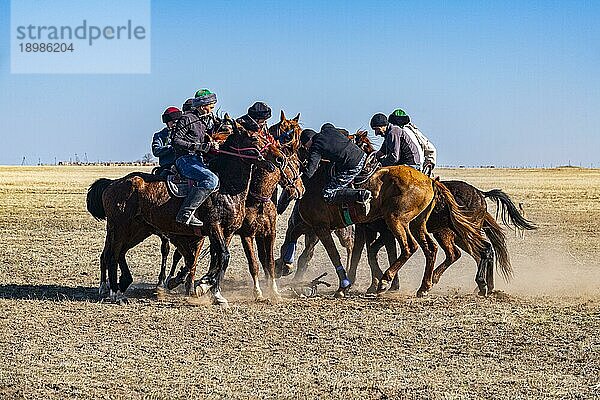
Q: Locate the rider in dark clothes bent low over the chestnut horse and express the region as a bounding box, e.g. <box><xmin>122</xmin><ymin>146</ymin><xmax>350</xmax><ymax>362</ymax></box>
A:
<box><xmin>300</xmin><ymin>123</ymin><xmax>371</xmax><ymax>214</ymax></box>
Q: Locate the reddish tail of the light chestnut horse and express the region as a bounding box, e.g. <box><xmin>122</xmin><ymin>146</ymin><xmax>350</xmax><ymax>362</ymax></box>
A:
<box><xmin>433</xmin><ymin>179</ymin><xmax>485</xmax><ymax>253</ymax></box>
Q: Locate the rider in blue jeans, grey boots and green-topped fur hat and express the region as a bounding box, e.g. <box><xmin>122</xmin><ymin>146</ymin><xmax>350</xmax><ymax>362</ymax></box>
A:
<box><xmin>171</xmin><ymin>89</ymin><xmax>219</xmax><ymax>227</ymax></box>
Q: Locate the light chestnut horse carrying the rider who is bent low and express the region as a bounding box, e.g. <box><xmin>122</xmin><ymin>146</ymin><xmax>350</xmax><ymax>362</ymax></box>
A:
<box><xmin>276</xmin><ymin>151</ymin><xmax>484</xmax><ymax>296</ymax></box>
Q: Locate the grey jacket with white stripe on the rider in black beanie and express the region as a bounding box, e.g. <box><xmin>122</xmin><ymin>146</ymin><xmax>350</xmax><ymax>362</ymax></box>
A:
<box><xmin>378</xmin><ymin>124</ymin><xmax>423</xmax><ymax>167</ymax></box>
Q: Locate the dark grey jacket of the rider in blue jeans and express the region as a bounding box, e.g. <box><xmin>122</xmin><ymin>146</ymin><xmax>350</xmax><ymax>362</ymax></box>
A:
<box><xmin>171</xmin><ymin>110</ymin><xmax>215</xmax><ymax>158</ymax></box>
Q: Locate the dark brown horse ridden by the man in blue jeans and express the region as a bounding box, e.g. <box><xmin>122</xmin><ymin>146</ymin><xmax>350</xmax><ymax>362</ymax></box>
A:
<box><xmin>88</xmin><ymin>131</ymin><xmax>285</xmax><ymax>305</ymax></box>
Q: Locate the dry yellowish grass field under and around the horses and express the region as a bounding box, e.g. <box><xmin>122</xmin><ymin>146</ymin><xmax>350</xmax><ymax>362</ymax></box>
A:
<box><xmin>0</xmin><ymin>167</ymin><xmax>600</xmax><ymax>399</ymax></box>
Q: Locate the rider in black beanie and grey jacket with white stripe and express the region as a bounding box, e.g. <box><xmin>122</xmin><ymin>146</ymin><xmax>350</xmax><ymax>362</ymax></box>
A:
<box><xmin>371</xmin><ymin>113</ymin><xmax>423</xmax><ymax>171</ymax></box>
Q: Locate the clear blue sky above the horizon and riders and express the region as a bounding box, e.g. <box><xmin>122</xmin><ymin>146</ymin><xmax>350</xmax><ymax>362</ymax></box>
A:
<box><xmin>0</xmin><ymin>0</ymin><xmax>600</xmax><ymax>166</ymax></box>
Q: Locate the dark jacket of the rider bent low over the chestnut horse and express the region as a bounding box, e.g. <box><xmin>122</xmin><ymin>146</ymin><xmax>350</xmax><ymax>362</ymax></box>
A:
<box><xmin>304</xmin><ymin>126</ymin><xmax>365</xmax><ymax>178</ymax></box>
